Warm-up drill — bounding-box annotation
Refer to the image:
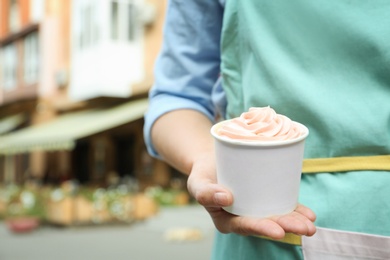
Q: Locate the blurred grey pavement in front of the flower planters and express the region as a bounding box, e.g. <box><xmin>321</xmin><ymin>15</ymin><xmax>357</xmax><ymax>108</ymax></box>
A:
<box><xmin>0</xmin><ymin>205</ymin><xmax>215</xmax><ymax>260</ymax></box>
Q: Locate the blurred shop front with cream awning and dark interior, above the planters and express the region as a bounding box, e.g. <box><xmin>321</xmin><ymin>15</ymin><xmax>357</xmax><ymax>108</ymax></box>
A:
<box><xmin>0</xmin><ymin>99</ymin><xmax>172</xmax><ymax>189</ymax></box>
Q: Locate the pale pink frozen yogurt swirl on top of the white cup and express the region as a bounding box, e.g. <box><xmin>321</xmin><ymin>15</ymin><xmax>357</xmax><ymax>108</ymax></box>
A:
<box><xmin>218</xmin><ymin>106</ymin><xmax>303</xmax><ymax>141</ymax></box>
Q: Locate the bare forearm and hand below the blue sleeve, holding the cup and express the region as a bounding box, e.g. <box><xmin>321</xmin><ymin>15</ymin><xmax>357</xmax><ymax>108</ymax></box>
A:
<box><xmin>152</xmin><ymin>109</ymin><xmax>316</xmax><ymax>239</ymax></box>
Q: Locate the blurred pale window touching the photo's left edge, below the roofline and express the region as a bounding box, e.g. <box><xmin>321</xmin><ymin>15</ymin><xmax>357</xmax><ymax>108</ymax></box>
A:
<box><xmin>2</xmin><ymin>43</ymin><xmax>17</xmax><ymax>91</ymax></box>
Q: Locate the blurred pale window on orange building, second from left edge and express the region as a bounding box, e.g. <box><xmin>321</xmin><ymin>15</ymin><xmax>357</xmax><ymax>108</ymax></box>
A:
<box><xmin>24</xmin><ymin>32</ymin><xmax>39</xmax><ymax>84</ymax></box>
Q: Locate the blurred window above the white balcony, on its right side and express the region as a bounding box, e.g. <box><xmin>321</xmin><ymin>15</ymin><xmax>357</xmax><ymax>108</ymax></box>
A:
<box><xmin>110</xmin><ymin>0</ymin><xmax>137</xmax><ymax>42</ymax></box>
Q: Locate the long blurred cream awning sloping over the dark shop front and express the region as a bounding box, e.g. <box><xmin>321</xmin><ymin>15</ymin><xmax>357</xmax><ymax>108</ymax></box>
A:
<box><xmin>0</xmin><ymin>99</ymin><xmax>148</xmax><ymax>154</ymax></box>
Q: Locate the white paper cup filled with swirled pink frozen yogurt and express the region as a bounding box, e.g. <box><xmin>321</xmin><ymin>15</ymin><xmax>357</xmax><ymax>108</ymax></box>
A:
<box><xmin>210</xmin><ymin>107</ymin><xmax>309</xmax><ymax>218</ymax></box>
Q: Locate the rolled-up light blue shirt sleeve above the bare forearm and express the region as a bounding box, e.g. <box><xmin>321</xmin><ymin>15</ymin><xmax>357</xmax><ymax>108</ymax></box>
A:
<box><xmin>144</xmin><ymin>0</ymin><xmax>224</xmax><ymax>157</ymax></box>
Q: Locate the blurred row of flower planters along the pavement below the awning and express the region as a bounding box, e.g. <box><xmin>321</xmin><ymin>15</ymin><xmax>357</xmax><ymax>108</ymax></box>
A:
<box><xmin>0</xmin><ymin>183</ymin><xmax>160</xmax><ymax>226</ymax></box>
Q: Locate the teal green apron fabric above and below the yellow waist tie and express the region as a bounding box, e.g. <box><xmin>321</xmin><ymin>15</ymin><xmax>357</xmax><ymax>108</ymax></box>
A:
<box><xmin>213</xmin><ymin>0</ymin><xmax>390</xmax><ymax>260</ymax></box>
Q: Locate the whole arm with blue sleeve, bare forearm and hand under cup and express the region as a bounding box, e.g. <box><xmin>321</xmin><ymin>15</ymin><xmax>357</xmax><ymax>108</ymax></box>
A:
<box><xmin>144</xmin><ymin>0</ymin><xmax>315</xmax><ymax>239</ymax></box>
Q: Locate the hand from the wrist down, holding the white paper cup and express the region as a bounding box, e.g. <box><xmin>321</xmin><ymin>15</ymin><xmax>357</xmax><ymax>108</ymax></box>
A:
<box><xmin>187</xmin><ymin>151</ymin><xmax>316</xmax><ymax>239</ymax></box>
